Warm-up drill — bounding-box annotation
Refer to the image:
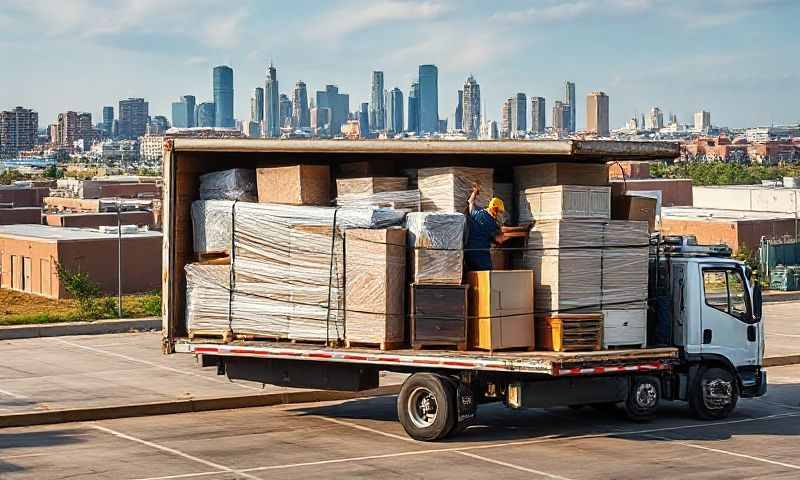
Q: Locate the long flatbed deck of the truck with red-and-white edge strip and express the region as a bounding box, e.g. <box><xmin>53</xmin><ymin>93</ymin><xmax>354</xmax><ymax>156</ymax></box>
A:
<box><xmin>175</xmin><ymin>339</ymin><xmax>678</xmax><ymax>377</ymax></box>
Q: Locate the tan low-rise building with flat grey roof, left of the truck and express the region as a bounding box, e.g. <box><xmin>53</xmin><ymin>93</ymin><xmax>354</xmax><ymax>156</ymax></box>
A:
<box><xmin>0</xmin><ymin>225</ymin><xmax>161</xmax><ymax>299</ymax></box>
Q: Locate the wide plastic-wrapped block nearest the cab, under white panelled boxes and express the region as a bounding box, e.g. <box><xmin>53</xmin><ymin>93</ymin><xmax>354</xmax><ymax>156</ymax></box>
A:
<box><xmin>520</xmin><ymin>220</ymin><xmax>649</xmax><ymax>314</ymax></box>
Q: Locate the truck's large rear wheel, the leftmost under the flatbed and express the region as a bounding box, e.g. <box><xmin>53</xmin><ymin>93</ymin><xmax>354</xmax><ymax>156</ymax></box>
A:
<box><xmin>397</xmin><ymin>373</ymin><xmax>458</xmax><ymax>442</ymax></box>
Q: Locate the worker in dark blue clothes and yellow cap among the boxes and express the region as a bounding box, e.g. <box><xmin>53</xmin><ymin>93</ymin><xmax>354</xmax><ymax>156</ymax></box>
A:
<box><xmin>464</xmin><ymin>184</ymin><xmax>507</xmax><ymax>271</ymax></box>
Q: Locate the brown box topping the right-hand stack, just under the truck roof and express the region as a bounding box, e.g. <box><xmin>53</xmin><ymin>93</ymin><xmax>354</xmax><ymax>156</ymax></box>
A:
<box><xmin>514</xmin><ymin>162</ymin><xmax>608</xmax><ymax>192</ymax></box>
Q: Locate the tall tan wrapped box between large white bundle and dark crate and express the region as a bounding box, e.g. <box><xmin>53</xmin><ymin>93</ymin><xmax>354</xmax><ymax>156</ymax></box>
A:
<box><xmin>345</xmin><ymin>227</ymin><xmax>406</xmax><ymax>350</ymax></box>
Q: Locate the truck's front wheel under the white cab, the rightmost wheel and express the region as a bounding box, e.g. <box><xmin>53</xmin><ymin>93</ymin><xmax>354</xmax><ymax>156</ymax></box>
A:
<box><xmin>689</xmin><ymin>367</ymin><xmax>739</xmax><ymax>420</ymax></box>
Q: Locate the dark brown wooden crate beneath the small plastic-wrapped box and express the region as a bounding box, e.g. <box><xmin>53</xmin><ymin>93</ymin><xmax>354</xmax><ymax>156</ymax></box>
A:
<box><xmin>410</xmin><ymin>284</ymin><xmax>469</xmax><ymax>350</ymax></box>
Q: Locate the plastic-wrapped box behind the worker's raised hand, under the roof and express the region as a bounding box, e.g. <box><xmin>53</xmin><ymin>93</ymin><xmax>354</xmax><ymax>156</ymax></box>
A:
<box><xmin>417</xmin><ymin>167</ymin><xmax>494</xmax><ymax>213</ymax></box>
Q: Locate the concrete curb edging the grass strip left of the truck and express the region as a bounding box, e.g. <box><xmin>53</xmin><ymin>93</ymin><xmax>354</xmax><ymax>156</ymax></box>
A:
<box><xmin>0</xmin><ymin>317</ymin><xmax>161</xmax><ymax>340</ymax></box>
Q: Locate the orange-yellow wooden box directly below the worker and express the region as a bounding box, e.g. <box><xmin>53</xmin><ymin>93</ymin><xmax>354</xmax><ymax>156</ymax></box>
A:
<box><xmin>469</xmin><ymin>270</ymin><xmax>534</xmax><ymax>351</ymax></box>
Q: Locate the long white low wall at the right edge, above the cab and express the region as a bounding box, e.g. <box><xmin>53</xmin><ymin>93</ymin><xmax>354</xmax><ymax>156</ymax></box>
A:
<box><xmin>693</xmin><ymin>186</ymin><xmax>800</xmax><ymax>213</ymax></box>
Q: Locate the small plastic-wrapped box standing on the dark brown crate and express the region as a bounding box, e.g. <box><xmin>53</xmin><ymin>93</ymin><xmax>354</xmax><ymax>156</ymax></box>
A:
<box><xmin>406</xmin><ymin>212</ymin><xmax>466</xmax><ymax>285</ymax></box>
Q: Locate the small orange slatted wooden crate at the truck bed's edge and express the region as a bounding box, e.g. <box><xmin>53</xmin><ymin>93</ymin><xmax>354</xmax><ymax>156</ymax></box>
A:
<box><xmin>535</xmin><ymin>313</ymin><xmax>603</xmax><ymax>352</ymax></box>
